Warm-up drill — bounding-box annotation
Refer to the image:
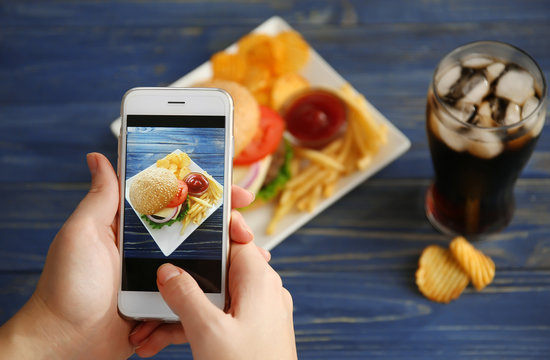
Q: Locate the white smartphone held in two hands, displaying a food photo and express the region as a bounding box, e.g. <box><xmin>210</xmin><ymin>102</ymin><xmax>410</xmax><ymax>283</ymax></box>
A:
<box><xmin>118</xmin><ymin>88</ymin><xmax>233</xmax><ymax>321</ymax></box>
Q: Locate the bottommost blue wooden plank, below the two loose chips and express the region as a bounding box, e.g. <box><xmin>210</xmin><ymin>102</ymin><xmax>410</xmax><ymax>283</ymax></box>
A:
<box><xmin>0</xmin><ymin>270</ymin><xmax>550</xmax><ymax>359</ymax></box>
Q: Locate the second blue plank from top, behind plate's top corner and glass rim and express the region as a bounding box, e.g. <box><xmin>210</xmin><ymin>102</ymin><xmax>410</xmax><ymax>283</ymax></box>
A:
<box><xmin>0</xmin><ymin>19</ymin><xmax>550</xmax><ymax>105</ymax></box>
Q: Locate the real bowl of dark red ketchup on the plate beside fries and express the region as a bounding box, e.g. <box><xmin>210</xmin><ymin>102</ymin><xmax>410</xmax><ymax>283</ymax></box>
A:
<box><xmin>283</xmin><ymin>89</ymin><xmax>346</xmax><ymax>147</ymax></box>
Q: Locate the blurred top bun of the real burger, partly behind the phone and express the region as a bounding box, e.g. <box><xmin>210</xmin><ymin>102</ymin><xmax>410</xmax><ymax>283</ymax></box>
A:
<box><xmin>195</xmin><ymin>79</ymin><xmax>260</xmax><ymax>156</ymax></box>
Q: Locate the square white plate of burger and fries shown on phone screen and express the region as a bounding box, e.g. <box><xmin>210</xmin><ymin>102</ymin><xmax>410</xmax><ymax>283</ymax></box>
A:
<box><xmin>126</xmin><ymin>149</ymin><xmax>223</xmax><ymax>256</ymax></box>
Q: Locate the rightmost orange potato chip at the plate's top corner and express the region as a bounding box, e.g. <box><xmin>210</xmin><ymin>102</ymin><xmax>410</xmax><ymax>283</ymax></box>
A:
<box><xmin>273</xmin><ymin>31</ymin><xmax>310</xmax><ymax>75</ymax></box>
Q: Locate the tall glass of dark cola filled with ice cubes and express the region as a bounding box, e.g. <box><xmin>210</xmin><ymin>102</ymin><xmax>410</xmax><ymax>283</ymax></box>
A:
<box><xmin>426</xmin><ymin>41</ymin><xmax>547</xmax><ymax>236</ymax></box>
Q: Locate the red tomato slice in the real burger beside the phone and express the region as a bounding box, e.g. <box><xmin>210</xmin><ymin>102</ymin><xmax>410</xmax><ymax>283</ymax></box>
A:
<box><xmin>233</xmin><ymin>105</ymin><xmax>285</xmax><ymax>165</ymax></box>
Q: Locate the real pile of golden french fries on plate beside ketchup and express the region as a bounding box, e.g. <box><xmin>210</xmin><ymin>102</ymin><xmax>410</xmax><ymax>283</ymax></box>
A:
<box><xmin>266</xmin><ymin>84</ymin><xmax>388</xmax><ymax>235</ymax></box>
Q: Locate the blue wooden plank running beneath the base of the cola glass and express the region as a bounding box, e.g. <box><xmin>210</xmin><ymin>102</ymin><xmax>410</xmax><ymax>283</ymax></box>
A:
<box><xmin>0</xmin><ymin>179</ymin><xmax>550</xmax><ymax>271</ymax></box>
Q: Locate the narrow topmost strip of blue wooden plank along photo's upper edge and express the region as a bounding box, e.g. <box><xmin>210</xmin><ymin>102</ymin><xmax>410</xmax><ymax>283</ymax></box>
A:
<box><xmin>1</xmin><ymin>0</ymin><xmax>548</xmax><ymax>27</ymax></box>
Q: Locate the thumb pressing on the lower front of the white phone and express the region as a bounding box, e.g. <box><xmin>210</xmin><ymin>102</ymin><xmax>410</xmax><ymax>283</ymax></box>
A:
<box><xmin>157</xmin><ymin>263</ymin><xmax>223</xmax><ymax>334</ymax></box>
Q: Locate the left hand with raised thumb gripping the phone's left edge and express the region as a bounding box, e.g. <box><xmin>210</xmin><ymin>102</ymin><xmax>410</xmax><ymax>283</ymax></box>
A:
<box><xmin>0</xmin><ymin>153</ymin><xmax>134</xmax><ymax>359</ymax></box>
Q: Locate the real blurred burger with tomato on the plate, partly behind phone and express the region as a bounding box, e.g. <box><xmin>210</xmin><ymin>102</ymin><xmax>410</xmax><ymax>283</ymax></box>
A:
<box><xmin>196</xmin><ymin>80</ymin><xmax>292</xmax><ymax>203</ymax></box>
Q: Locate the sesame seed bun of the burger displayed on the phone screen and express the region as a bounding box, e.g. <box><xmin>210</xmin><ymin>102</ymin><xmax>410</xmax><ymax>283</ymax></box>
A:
<box><xmin>130</xmin><ymin>166</ymin><xmax>178</xmax><ymax>215</ymax></box>
